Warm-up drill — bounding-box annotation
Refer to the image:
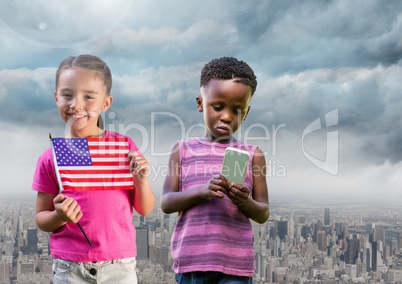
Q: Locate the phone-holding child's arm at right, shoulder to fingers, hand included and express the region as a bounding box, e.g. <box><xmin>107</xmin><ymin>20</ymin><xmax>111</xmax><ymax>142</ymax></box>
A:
<box><xmin>228</xmin><ymin>148</ymin><xmax>269</xmax><ymax>224</ymax></box>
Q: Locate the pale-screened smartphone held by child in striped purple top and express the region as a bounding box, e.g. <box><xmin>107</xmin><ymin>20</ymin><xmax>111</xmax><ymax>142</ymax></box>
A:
<box><xmin>221</xmin><ymin>147</ymin><xmax>250</xmax><ymax>184</ymax></box>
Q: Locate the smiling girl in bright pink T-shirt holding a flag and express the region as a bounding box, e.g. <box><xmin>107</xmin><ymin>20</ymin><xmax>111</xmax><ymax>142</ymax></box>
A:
<box><xmin>32</xmin><ymin>55</ymin><xmax>155</xmax><ymax>283</ymax></box>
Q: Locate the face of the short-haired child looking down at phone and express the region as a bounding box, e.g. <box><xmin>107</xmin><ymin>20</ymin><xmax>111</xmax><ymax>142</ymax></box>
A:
<box><xmin>196</xmin><ymin>78</ymin><xmax>251</xmax><ymax>143</ymax></box>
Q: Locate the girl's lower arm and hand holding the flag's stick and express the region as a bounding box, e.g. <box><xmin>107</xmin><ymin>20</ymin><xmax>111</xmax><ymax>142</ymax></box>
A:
<box><xmin>36</xmin><ymin>192</ymin><xmax>82</xmax><ymax>232</ymax></box>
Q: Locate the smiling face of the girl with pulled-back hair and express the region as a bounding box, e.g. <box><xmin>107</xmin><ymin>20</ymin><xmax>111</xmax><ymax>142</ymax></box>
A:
<box><xmin>54</xmin><ymin>67</ymin><xmax>113</xmax><ymax>137</ymax></box>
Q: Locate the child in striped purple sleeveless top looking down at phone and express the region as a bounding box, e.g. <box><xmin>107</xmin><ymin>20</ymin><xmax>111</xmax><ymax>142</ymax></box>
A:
<box><xmin>161</xmin><ymin>57</ymin><xmax>269</xmax><ymax>284</ymax></box>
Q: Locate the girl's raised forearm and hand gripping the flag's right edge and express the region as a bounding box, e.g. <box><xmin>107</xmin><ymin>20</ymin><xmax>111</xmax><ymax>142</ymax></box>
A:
<box><xmin>128</xmin><ymin>151</ymin><xmax>155</xmax><ymax>216</ymax></box>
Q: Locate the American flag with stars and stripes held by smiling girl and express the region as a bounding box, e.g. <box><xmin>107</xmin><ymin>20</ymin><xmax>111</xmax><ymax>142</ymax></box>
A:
<box><xmin>51</xmin><ymin>138</ymin><xmax>134</xmax><ymax>190</ymax></box>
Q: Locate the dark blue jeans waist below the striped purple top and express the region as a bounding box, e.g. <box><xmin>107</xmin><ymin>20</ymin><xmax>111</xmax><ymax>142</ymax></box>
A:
<box><xmin>176</xmin><ymin>271</ymin><xmax>253</xmax><ymax>284</ymax></box>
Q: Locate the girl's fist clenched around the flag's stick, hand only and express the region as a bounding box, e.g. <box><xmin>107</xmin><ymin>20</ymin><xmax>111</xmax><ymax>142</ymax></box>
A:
<box><xmin>53</xmin><ymin>193</ymin><xmax>82</xmax><ymax>223</ymax></box>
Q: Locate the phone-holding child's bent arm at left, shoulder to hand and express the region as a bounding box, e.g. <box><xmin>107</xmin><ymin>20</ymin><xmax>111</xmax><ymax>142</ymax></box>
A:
<box><xmin>161</xmin><ymin>143</ymin><xmax>226</xmax><ymax>214</ymax></box>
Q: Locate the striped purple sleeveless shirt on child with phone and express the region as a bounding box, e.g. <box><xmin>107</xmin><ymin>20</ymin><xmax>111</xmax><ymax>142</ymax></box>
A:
<box><xmin>171</xmin><ymin>138</ymin><xmax>256</xmax><ymax>277</ymax></box>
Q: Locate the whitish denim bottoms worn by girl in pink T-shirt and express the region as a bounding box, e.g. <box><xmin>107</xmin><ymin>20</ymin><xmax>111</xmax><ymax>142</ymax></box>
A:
<box><xmin>52</xmin><ymin>257</ymin><xmax>137</xmax><ymax>284</ymax></box>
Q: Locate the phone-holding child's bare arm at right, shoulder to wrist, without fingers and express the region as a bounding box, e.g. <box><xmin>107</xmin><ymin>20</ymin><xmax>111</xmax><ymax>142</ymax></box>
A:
<box><xmin>239</xmin><ymin>148</ymin><xmax>269</xmax><ymax>224</ymax></box>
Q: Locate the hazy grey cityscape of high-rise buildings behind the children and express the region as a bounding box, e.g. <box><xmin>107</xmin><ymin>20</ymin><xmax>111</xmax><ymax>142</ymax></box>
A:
<box><xmin>0</xmin><ymin>198</ymin><xmax>402</xmax><ymax>284</ymax></box>
